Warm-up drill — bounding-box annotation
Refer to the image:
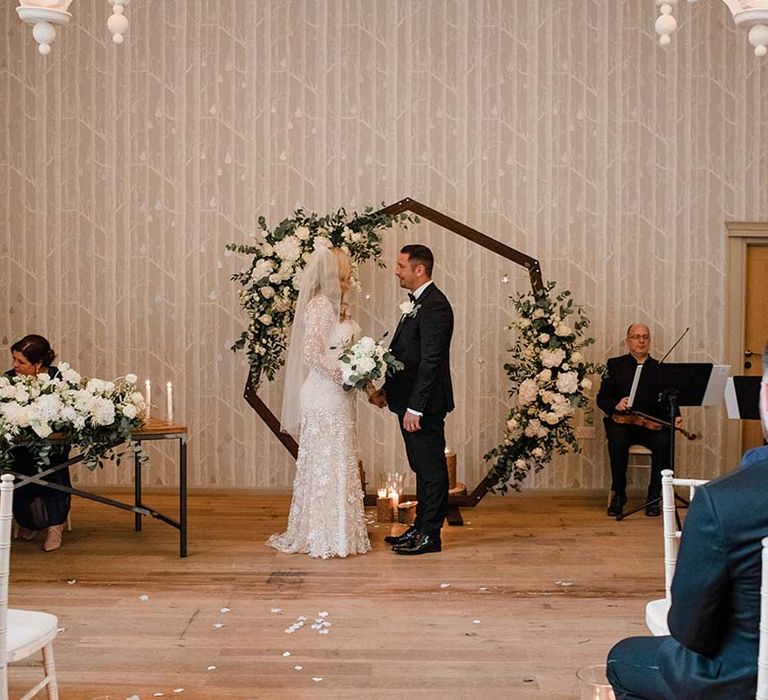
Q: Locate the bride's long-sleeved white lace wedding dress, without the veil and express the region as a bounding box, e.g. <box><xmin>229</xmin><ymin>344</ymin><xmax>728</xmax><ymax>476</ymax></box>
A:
<box><xmin>267</xmin><ymin>296</ymin><xmax>371</xmax><ymax>559</ymax></box>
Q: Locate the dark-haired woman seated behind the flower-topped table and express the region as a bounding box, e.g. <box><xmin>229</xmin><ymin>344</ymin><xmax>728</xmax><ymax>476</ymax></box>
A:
<box><xmin>6</xmin><ymin>335</ymin><xmax>72</xmax><ymax>552</ymax></box>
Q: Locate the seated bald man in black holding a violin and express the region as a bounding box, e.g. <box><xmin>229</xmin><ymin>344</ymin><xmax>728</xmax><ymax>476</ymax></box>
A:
<box><xmin>597</xmin><ymin>323</ymin><xmax>680</xmax><ymax>517</ymax></box>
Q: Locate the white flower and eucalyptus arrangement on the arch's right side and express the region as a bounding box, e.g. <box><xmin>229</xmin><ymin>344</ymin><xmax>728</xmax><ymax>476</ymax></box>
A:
<box><xmin>485</xmin><ymin>282</ymin><xmax>603</xmax><ymax>493</ymax></box>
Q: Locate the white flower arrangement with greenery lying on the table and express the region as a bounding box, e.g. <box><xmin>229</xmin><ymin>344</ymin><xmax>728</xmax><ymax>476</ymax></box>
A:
<box><xmin>0</xmin><ymin>362</ymin><xmax>146</xmax><ymax>469</ymax></box>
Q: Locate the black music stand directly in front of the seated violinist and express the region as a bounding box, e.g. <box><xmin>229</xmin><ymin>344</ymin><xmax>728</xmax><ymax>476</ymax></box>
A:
<box><xmin>616</xmin><ymin>362</ymin><xmax>730</xmax><ymax>520</ymax></box>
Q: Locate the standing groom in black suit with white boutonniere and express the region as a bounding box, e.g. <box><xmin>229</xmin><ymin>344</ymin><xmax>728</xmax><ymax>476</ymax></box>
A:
<box><xmin>371</xmin><ymin>245</ymin><xmax>453</xmax><ymax>554</ymax></box>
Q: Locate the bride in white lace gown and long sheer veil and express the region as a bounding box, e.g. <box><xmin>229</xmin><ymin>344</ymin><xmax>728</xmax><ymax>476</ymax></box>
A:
<box><xmin>267</xmin><ymin>247</ymin><xmax>371</xmax><ymax>559</ymax></box>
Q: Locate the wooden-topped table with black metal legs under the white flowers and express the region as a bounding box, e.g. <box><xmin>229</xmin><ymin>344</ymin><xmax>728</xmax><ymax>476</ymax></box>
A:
<box><xmin>12</xmin><ymin>418</ymin><xmax>187</xmax><ymax>558</ymax></box>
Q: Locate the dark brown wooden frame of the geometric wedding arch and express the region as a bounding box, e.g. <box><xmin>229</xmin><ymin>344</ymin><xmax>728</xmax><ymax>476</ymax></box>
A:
<box><xmin>244</xmin><ymin>197</ymin><xmax>544</xmax><ymax>525</ymax></box>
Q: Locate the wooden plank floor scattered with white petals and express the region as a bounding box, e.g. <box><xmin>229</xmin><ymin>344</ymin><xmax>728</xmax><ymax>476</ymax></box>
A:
<box><xmin>10</xmin><ymin>492</ymin><xmax>663</xmax><ymax>700</ymax></box>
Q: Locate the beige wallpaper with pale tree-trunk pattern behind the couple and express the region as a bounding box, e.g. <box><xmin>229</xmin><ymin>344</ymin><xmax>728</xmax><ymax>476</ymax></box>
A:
<box><xmin>0</xmin><ymin>0</ymin><xmax>768</xmax><ymax>489</ymax></box>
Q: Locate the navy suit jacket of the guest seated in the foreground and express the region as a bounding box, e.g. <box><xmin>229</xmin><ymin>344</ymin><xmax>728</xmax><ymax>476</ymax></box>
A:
<box><xmin>658</xmin><ymin>458</ymin><xmax>768</xmax><ymax>700</ymax></box>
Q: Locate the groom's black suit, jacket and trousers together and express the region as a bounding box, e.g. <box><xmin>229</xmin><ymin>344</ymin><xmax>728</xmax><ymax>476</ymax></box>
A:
<box><xmin>384</xmin><ymin>282</ymin><xmax>454</xmax><ymax>539</ymax></box>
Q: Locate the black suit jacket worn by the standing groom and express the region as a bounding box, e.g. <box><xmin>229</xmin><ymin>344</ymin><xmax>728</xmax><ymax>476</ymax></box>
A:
<box><xmin>384</xmin><ymin>282</ymin><xmax>454</xmax><ymax>415</ymax></box>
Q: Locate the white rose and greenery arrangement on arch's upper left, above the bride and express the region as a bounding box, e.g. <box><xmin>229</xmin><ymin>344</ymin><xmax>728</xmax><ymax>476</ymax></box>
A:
<box><xmin>226</xmin><ymin>207</ymin><xmax>418</xmax><ymax>388</ymax></box>
